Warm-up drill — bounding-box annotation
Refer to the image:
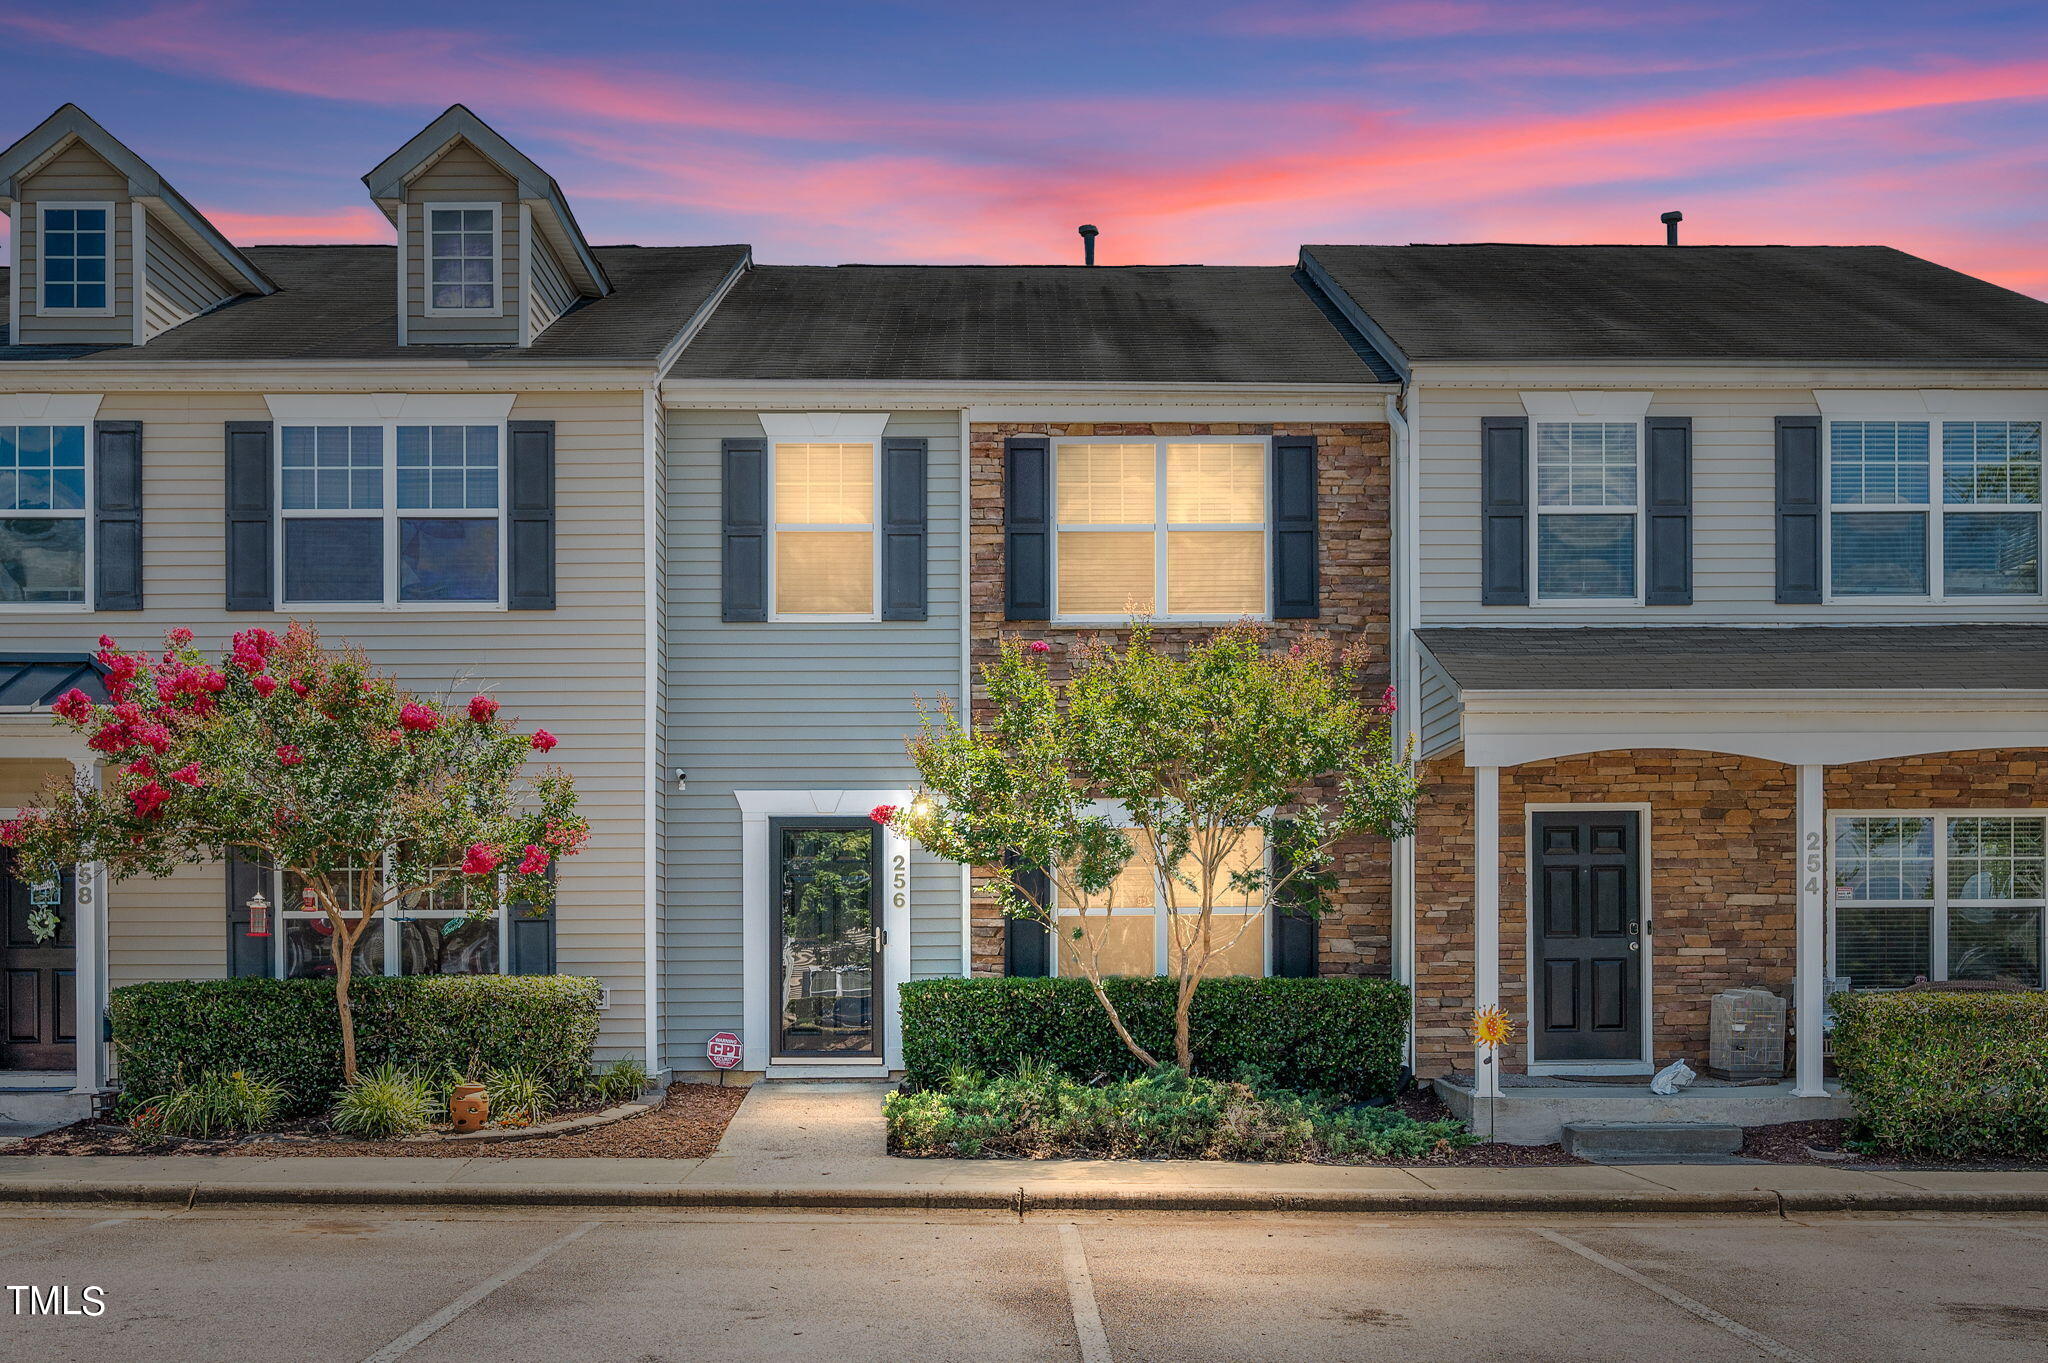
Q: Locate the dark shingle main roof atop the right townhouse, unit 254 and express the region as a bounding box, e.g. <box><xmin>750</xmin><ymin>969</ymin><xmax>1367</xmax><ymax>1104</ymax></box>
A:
<box><xmin>1303</xmin><ymin>244</ymin><xmax>2048</xmax><ymax>362</ymax></box>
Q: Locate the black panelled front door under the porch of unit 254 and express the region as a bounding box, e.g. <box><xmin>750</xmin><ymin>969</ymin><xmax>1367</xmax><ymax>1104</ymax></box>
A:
<box><xmin>1530</xmin><ymin>810</ymin><xmax>1642</xmax><ymax>1060</ymax></box>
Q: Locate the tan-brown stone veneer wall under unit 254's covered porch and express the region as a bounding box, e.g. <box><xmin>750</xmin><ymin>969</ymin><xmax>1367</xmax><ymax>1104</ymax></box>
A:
<box><xmin>1415</xmin><ymin>749</ymin><xmax>2048</xmax><ymax>1074</ymax></box>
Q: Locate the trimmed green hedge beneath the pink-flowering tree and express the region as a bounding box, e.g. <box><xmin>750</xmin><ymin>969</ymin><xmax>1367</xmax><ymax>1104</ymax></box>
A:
<box><xmin>109</xmin><ymin>974</ymin><xmax>598</xmax><ymax>1117</ymax></box>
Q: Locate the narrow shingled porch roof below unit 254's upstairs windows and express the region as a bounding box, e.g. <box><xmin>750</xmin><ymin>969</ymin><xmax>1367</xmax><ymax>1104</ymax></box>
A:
<box><xmin>1415</xmin><ymin>624</ymin><xmax>2048</xmax><ymax>692</ymax></box>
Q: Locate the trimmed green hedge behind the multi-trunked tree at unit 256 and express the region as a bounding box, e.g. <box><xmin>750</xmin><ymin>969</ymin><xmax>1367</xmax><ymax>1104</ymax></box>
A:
<box><xmin>901</xmin><ymin>978</ymin><xmax>1409</xmax><ymax>1097</ymax></box>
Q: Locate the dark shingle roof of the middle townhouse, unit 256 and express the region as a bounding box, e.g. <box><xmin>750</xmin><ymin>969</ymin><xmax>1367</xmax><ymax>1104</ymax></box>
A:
<box><xmin>668</xmin><ymin>266</ymin><xmax>1393</xmax><ymax>383</ymax></box>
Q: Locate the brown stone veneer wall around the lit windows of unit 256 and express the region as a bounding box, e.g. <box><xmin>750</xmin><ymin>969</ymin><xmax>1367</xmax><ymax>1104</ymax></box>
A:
<box><xmin>969</xmin><ymin>422</ymin><xmax>1393</xmax><ymax>974</ymax></box>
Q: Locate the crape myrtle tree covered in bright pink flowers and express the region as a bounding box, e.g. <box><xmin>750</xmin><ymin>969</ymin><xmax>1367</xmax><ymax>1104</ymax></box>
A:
<box><xmin>0</xmin><ymin>624</ymin><xmax>590</xmax><ymax>1083</ymax></box>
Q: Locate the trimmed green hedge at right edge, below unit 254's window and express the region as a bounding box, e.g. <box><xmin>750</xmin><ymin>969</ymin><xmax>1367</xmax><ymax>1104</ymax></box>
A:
<box><xmin>1831</xmin><ymin>991</ymin><xmax>2048</xmax><ymax>1156</ymax></box>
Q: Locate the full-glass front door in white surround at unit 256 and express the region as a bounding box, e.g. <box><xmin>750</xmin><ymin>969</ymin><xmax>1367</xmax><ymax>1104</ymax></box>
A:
<box><xmin>770</xmin><ymin>819</ymin><xmax>883</xmax><ymax>1060</ymax></box>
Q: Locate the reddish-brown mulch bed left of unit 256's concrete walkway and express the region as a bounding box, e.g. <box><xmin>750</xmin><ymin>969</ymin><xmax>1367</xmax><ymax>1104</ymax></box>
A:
<box><xmin>0</xmin><ymin>1083</ymin><xmax>748</xmax><ymax>1160</ymax></box>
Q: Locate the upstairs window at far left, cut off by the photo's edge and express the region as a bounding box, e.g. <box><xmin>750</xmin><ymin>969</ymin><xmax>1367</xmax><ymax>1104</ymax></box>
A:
<box><xmin>0</xmin><ymin>426</ymin><xmax>92</xmax><ymax>606</ymax></box>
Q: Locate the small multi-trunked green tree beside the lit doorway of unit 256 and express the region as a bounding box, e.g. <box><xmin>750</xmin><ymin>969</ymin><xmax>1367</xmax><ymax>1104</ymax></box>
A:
<box><xmin>874</xmin><ymin>622</ymin><xmax>1415</xmax><ymax>1068</ymax></box>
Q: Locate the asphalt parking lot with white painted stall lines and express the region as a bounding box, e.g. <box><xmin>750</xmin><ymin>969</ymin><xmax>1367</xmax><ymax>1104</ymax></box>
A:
<box><xmin>0</xmin><ymin>1207</ymin><xmax>2048</xmax><ymax>1363</ymax></box>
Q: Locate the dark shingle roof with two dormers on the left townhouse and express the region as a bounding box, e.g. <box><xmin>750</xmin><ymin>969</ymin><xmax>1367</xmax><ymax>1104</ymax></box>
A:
<box><xmin>0</xmin><ymin>246</ymin><xmax>748</xmax><ymax>364</ymax></box>
